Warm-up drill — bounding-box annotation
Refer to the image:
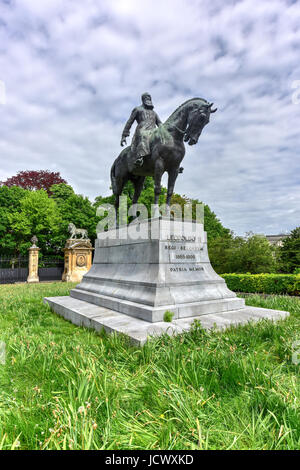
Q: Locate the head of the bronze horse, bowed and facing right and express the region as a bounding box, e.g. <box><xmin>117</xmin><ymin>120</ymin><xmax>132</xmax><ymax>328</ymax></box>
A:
<box><xmin>184</xmin><ymin>103</ymin><xmax>217</xmax><ymax>145</ymax></box>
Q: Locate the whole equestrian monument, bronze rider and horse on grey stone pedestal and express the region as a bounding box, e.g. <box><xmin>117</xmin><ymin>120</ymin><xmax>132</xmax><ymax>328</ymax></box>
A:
<box><xmin>45</xmin><ymin>93</ymin><xmax>288</xmax><ymax>344</ymax></box>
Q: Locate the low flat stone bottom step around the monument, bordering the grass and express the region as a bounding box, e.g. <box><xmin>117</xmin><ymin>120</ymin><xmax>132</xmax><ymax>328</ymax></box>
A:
<box><xmin>44</xmin><ymin>296</ymin><xmax>289</xmax><ymax>346</ymax></box>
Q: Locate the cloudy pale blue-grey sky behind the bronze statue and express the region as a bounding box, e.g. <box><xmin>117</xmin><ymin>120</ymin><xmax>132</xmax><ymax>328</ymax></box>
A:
<box><xmin>0</xmin><ymin>0</ymin><xmax>300</xmax><ymax>234</ymax></box>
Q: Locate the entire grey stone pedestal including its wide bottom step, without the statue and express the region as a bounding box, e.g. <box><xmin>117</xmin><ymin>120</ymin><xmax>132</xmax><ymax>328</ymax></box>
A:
<box><xmin>45</xmin><ymin>218</ymin><xmax>287</xmax><ymax>344</ymax></box>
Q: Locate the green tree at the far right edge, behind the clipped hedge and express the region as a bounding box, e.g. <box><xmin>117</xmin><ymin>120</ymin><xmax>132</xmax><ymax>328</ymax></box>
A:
<box><xmin>279</xmin><ymin>227</ymin><xmax>300</xmax><ymax>273</ymax></box>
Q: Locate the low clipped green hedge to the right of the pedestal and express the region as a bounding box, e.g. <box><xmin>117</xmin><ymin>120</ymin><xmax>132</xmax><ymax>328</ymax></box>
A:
<box><xmin>221</xmin><ymin>273</ymin><xmax>300</xmax><ymax>295</ymax></box>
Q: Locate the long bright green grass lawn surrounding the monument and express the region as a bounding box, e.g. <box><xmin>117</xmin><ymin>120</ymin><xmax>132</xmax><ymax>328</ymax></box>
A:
<box><xmin>0</xmin><ymin>283</ymin><xmax>300</xmax><ymax>449</ymax></box>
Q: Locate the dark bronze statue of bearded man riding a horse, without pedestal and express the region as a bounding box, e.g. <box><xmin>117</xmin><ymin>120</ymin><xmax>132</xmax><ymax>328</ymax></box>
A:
<box><xmin>111</xmin><ymin>93</ymin><xmax>217</xmax><ymax>217</ymax></box>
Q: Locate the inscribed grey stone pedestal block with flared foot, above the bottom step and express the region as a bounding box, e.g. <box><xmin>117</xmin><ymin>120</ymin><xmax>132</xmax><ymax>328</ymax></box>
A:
<box><xmin>70</xmin><ymin>218</ymin><xmax>244</xmax><ymax>323</ymax></box>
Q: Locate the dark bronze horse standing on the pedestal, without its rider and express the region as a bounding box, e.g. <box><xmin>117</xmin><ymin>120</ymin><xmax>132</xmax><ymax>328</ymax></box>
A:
<box><xmin>111</xmin><ymin>98</ymin><xmax>217</xmax><ymax>216</ymax></box>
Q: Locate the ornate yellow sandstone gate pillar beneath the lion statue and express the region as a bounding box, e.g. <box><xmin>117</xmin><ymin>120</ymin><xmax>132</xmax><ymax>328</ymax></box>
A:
<box><xmin>62</xmin><ymin>238</ymin><xmax>94</xmax><ymax>282</ymax></box>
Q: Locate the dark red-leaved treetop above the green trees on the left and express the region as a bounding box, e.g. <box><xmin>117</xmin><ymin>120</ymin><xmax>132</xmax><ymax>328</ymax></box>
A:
<box><xmin>1</xmin><ymin>170</ymin><xmax>67</xmax><ymax>194</ymax></box>
